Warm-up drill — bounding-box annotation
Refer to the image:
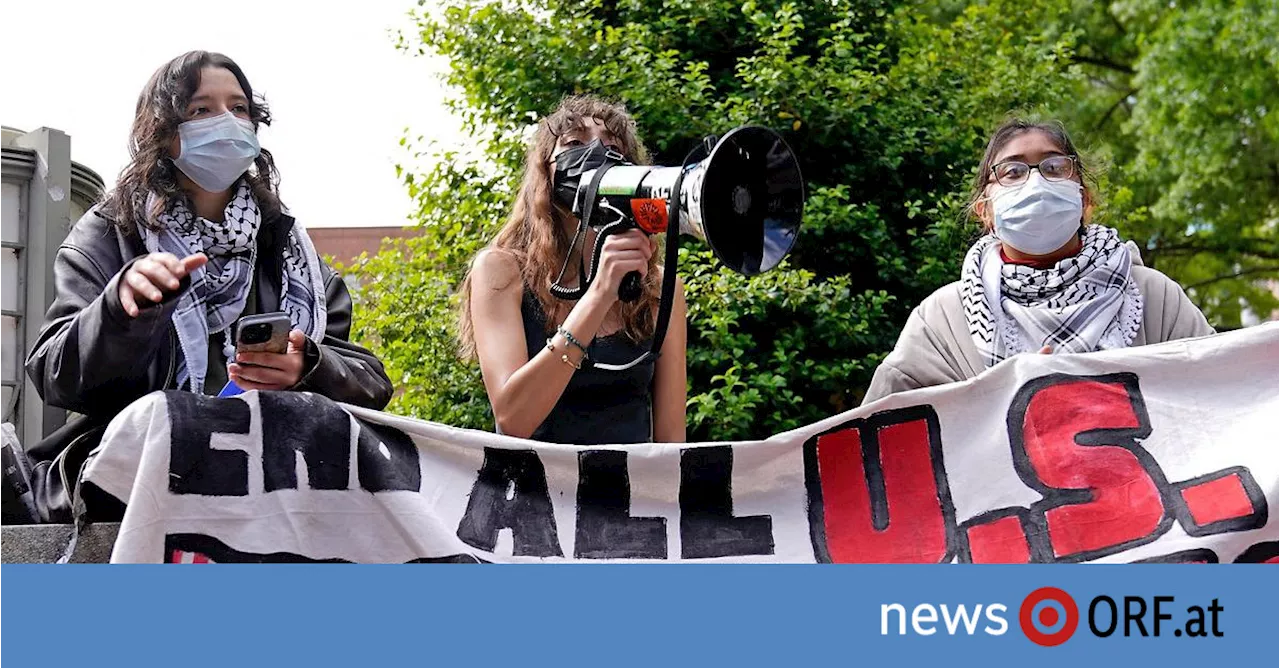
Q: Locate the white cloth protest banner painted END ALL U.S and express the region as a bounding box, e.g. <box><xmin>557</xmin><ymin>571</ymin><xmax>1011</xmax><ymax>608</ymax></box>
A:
<box><xmin>86</xmin><ymin>324</ymin><xmax>1280</xmax><ymax>563</ymax></box>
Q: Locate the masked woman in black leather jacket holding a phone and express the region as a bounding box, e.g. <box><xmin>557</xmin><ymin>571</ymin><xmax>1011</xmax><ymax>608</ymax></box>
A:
<box><xmin>27</xmin><ymin>51</ymin><xmax>392</xmax><ymax>519</ymax></box>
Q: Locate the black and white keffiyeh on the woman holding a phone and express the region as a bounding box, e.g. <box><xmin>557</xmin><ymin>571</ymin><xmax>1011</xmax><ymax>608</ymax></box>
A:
<box><xmin>142</xmin><ymin>182</ymin><xmax>328</xmax><ymax>393</ymax></box>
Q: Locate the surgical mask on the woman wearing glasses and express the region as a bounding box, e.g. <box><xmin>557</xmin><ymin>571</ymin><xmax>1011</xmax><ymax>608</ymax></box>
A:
<box><xmin>991</xmin><ymin>171</ymin><xmax>1084</xmax><ymax>255</ymax></box>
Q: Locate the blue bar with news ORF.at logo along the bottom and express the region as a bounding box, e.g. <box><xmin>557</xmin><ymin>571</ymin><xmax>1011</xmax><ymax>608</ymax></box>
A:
<box><xmin>0</xmin><ymin>564</ymin><xmax>1280</xmax><ymax>668</ymax></box>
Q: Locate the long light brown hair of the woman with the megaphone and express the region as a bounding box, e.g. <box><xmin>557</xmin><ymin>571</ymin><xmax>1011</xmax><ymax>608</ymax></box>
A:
<box><xmin>458</xmin><ymin>95</ymin><xmax>662</xmax><ymax>358</ymax></box>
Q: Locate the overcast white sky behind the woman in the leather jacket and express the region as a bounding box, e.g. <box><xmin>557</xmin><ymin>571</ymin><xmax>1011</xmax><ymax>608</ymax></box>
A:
<box><xmin>0</xmin><ymin>0</ymin><xmax>460</xmax><ymax>227</ymax></box>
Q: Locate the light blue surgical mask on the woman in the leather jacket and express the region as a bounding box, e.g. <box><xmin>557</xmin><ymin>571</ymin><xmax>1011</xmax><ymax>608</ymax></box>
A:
<box><xmin>173</xmin><ymin>111</ymin><xmax>262</xmax><ymax>192</ymax></box>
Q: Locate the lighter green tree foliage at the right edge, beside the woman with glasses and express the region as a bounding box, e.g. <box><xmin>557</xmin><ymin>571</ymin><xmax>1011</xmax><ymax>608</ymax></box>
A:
<box><xmin>1064</xmin><ymin>0</ymin><xmax>1280</xmax><ymax>328</ymax></box>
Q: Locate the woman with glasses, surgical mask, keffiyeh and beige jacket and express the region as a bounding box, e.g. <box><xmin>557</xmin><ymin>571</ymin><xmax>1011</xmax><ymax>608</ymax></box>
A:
<box><xmin>864</xmin><ymin>119</ymin><xmax>1213</xmax><ymax>403</ymax></box>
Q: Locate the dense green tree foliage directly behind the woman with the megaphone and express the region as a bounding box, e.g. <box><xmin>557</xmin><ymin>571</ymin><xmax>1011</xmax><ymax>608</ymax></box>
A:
<box><xmin>349</xmin><ymin>0</ymin><xmax>1076</xmax><ymax>439</ymax></box>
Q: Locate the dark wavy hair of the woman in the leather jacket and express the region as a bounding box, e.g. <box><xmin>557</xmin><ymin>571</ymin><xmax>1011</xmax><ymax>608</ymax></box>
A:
<box><xmin>104</xmin><ymin>51</ymin><xmax>280</xmax><ymax>232</ymax></box>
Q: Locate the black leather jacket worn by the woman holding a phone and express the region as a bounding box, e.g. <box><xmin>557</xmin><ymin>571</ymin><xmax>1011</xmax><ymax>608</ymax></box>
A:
<box><xmin>27</xmin><ymin>207</ymin><xmax>392</xmax><ymax>461</ymax></box>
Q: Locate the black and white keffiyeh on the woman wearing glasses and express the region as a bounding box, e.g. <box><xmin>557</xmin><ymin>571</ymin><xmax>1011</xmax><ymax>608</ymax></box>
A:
<box><xmin>960</xmin><ymin>225</ymin><xmax>1143</xmax><ymax>367</ymax></box>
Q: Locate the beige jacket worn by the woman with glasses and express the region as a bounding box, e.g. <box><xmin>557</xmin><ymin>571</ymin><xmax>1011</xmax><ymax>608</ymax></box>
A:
<box><xmin>863</xmin><ymin>265</ymin><xmax>1213</xmax><ymax>404</ymax></box>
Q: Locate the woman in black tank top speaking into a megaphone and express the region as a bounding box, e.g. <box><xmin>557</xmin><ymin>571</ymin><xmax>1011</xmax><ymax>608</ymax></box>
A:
<box><xmin>460</xmin><ymin>96</ymin><xmax>686</xmax><ymax>445</ymax></box>
